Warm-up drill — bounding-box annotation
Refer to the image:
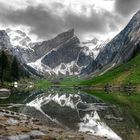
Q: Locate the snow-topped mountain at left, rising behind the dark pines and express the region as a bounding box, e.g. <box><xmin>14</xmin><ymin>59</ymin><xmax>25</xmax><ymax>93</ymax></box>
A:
<box><xmin>0</xmin><ymin>30</ymin><xmax>40</xmax><ymax>81</ymax></box>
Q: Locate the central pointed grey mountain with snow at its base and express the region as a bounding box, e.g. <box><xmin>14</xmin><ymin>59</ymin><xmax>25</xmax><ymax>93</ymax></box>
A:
<box><xmin>28</xmin><ymin>29</ymin><xmax>106</xmax><ymax>75</ymax></box>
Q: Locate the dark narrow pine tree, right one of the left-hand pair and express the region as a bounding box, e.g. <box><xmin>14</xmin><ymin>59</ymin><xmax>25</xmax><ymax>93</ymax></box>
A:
<box><xmin>11</xmin><ymin>56</ymin><xmax>19</xmax><ymax>81</ymax></box>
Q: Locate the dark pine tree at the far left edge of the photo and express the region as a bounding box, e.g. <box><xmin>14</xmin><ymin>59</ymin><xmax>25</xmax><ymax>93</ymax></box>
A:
<box><xmin>0</xmin><ymin>50</ymin><xmax>8</xmax><ymax>85</ymax></box>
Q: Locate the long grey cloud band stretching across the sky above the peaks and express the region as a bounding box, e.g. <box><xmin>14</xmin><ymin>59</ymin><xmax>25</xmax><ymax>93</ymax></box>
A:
<box><xmin>0</xmin><ymin>0</ymin><xmax>130</xmax><ymax>39</ymax></box>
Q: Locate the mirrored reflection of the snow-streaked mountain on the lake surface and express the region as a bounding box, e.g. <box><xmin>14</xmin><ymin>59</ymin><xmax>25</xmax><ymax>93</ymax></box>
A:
<box><xmin>23</xmin><ymin>89</ymin><xmax>130</xmax><ymax>140</ymax></box>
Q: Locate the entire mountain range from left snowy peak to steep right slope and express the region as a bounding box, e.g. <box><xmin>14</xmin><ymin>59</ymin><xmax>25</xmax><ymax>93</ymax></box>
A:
<box><xmin>0</xmin><ymin>11</ymin><xmax>140</xmax><ymax>76</ymax></box>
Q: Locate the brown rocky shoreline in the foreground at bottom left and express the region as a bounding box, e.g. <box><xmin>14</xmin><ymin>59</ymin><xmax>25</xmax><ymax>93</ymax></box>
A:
<box><xmin>0</xmin><ymin>109</ymin><xmax>106</xmax><ymax>140</ymax></box>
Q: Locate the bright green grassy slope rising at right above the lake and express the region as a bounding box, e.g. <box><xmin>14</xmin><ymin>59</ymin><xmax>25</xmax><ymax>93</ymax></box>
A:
<box><xmin>80</xmin><ymin>55</ymin><xmax>140</xmax><ymax>85</ymax></box>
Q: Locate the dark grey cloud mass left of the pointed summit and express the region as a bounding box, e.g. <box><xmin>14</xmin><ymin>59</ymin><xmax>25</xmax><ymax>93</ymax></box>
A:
<box><xmin>0</xmin><ymin>3</ymin><xmax>63</xmax><ymax>38</ymax></box>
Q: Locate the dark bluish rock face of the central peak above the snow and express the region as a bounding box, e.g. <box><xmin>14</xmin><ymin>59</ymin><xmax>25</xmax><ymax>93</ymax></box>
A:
<box><xmin>41</xmin><ymin>36</ymin><xmax>82</xmax><ymax>68</ymax></box>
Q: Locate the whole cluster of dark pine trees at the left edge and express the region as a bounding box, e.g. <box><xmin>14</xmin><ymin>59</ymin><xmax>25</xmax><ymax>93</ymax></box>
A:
<box><xmin>0</xmin><ymin>50</ymin><xmax>27</xmax><ymax>84</ymax></box>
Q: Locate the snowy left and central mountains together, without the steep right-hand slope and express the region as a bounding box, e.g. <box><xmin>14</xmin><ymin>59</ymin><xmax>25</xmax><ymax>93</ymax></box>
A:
<box><xmin>0</xmin><ymin>28</ymin><xmax>105</xmax><ymax>75</ymax></box>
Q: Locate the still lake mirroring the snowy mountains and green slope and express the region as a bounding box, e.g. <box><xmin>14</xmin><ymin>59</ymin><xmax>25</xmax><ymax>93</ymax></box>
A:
<box><xmin>0</xmin><ymin>87</ymin><xmax>140</xmax><ymax>140</ymax></box>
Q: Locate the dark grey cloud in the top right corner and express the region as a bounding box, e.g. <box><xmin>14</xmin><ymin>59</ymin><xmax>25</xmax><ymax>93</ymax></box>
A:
<box><xmin>115</xmin><ymin>0</ymin><xmax>140</xmax><ymax>16</ymax></box>
